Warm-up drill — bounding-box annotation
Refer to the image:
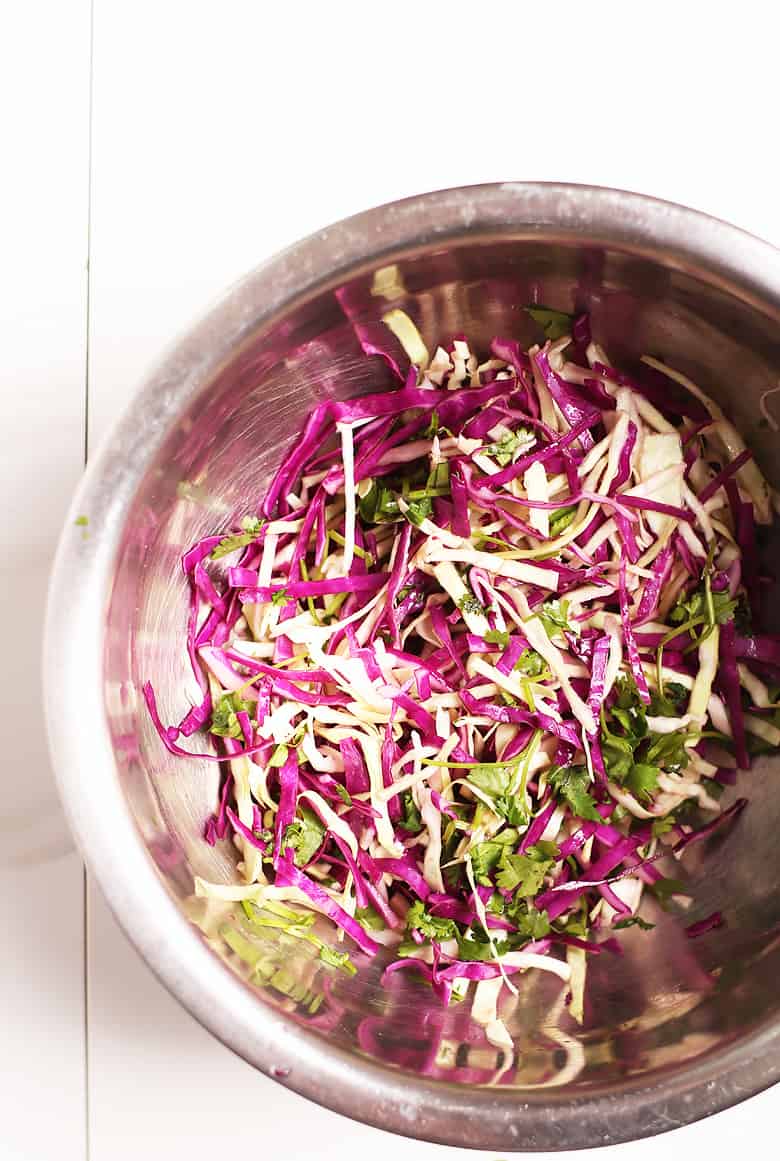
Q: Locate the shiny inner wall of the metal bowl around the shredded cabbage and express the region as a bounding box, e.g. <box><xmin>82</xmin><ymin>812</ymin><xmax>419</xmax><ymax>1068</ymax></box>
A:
<box><xmin>104</xmin><ymin>221</ymin><xmax>780</xmax><ymax>1119</ymax></box>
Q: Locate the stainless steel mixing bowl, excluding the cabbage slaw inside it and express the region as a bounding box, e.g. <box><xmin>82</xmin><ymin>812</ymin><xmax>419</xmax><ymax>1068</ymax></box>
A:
<box><xmin>45</xmin><ymin>185</ymin><xmax>780</xmax><ymax>1152</ymax></box>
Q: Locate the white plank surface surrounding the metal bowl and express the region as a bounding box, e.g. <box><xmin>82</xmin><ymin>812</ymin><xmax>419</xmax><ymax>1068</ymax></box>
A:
<box><xmin>0</xmin><ymin>0</ymin><xmax>780</xmax><ymax>1161</ymax></box>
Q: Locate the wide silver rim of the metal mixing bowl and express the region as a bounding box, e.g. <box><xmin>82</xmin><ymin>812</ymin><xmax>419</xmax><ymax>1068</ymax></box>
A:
<box><xmin>44</xmin><ymin>182</ymin><xmax>780</xmax><ymax>1151</ymax></box>
